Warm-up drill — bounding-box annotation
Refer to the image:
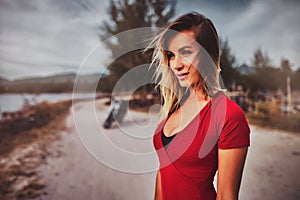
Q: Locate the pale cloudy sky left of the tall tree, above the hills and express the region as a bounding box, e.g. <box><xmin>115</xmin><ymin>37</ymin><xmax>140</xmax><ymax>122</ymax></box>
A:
<box><xmin>0</xmin><ymin>0</ymin><xmax>107</xmax><ymax>78</ymax></box>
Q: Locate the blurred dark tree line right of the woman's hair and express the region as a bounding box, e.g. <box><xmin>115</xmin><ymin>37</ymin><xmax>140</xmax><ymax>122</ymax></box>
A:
<box><xmin>220</xmin><ymin>41</ymin><xmax>300</xmax><ymax>93</ymax></box>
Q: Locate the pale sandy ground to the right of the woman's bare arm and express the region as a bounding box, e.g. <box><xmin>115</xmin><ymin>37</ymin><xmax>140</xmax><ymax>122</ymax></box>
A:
<box><xmin>240</xmin><ymin>126</ymin><xmax>300</xmax><ymax>200</ymax></box>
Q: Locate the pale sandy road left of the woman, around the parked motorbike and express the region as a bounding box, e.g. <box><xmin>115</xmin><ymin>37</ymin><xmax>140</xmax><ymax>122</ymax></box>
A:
<box><xmin>38</xmin><ymin>100</ymin><xmax>156</xmax><ymax>200</ymax></box>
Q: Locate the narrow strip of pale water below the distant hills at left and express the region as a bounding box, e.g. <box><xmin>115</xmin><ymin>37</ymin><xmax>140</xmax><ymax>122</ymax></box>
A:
<box><xmin>0</xmin><ymin>93</ymin><xmax>98</xmax><ymax>113</ymax></box>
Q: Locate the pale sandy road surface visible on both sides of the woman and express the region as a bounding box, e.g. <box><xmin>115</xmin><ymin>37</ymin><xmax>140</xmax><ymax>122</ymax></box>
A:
<box><xmin>28</xmin><ymin>101</ymin><xmax>300</xmax><ymax>200</ymax></box>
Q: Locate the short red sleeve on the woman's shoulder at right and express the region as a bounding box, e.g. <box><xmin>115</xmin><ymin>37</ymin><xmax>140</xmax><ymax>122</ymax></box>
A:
<box><xmin>218</xmin><ymin>100</ymin><xmax>250</xmax><ymax>149</ymax></box>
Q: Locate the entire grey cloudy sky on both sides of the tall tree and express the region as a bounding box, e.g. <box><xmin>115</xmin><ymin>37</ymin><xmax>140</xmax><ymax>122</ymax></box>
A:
<box><xmin>0</xmin><ymin>0</ymin><xmax>300</xmax><ymax>79</ymax></box>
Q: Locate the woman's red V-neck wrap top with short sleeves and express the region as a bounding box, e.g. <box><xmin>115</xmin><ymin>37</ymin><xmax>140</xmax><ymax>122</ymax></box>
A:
<box><xmin>153</xmin><ymin>93</ymin><xmax>250</xmax><ymax>200</ymax></box>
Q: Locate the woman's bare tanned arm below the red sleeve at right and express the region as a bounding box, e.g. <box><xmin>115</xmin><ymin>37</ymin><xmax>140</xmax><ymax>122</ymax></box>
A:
<box><xmin>217</xmin><ymin>147</ymin><xmax>248</xmax><ymax>200</ymax></box>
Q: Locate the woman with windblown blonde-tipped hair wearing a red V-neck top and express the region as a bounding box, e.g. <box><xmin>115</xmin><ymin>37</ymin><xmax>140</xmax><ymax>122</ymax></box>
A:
<box><xmin>150</xmin><ymin>13</ymin><xmax>250</xmax><ymax>200</ymax></box>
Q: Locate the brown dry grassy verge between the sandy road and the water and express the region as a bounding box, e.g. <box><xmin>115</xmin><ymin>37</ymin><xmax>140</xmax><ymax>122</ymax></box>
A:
<box><xmin>0</xmin><ymin>101</ymin><xmax>72</xmax><ymax>199</ymax></box>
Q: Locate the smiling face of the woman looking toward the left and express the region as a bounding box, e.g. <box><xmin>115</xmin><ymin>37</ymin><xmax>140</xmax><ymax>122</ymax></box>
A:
<box><xmin>167</xmin><ymin>31</ymin><xmax>201</xmax><ymax>87</ymax></box>
